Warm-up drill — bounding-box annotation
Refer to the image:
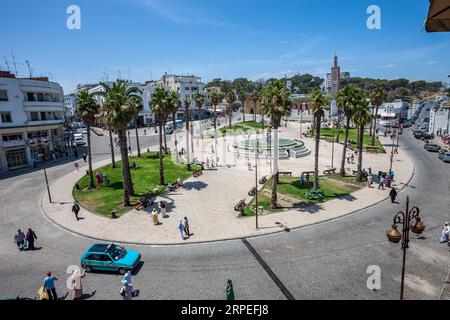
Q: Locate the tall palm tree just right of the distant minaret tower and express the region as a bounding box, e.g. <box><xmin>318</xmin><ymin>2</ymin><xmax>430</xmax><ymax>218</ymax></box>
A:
<box><xmin>336</xmin><ymin>85</ymin><xmax>358</xmax><ymax>177</ymax></box>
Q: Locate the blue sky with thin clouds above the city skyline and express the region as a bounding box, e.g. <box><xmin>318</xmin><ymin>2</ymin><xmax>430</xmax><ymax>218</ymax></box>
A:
<box><xmin>0</xmin><ymin>0</ymin><xmax>450</xmax><ymax>93</ymax></box>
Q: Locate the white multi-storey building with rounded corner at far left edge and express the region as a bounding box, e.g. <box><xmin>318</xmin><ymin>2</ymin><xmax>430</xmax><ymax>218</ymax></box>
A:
<box><xmin>0</xmin><ymin>71</ymin><xmax>65</xmax><ymax>172</ymax></box>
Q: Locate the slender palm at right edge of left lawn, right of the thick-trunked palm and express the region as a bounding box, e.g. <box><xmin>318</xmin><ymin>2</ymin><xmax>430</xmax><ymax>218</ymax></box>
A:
<box><xmin>151</xmin><ymin>88</ymin><xmax>169</xmax><ymax>186</ymax></box>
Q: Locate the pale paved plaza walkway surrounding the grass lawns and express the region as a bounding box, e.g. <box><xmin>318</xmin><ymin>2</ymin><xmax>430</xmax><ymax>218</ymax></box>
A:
<box><xmin>42</xmin><ymin>124</ymin><xmax>414</xmax><ymax>245</ymax></box>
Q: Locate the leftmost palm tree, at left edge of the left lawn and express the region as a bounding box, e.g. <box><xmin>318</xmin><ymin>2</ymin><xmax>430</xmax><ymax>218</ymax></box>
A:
<box><xmin>76</xmin><ymin>91</ymin><xmax>100</xmax><ymax>189</ymax></box>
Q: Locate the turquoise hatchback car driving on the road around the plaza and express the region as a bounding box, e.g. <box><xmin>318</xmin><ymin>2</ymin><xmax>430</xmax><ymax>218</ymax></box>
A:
<box><xmin>81</xmin><ymin>243</ymin><xmax>141</xmax><ymax>275</ymax></box>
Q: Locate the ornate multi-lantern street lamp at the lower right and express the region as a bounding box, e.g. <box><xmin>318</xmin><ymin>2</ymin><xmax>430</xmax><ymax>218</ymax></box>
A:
<box><xmin>386</xmin><ymin>196</ymin><xmax>425</xmax><ymax>300</ymax></box>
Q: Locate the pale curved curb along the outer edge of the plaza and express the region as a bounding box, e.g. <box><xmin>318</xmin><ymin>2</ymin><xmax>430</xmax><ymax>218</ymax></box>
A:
<box><xmin>39</xmin><ymin>136</ymin><xmax>416</xmax><ymax>247</ymax></box>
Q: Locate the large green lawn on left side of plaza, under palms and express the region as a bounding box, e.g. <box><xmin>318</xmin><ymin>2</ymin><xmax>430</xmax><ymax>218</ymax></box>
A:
<box><xmin>73</xmin><ymin>152</ymin><xmax>199</xmax><ymax>217</ymax></box>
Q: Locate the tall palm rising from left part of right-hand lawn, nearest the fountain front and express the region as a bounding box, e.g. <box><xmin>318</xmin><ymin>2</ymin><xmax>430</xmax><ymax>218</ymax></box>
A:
<box><xmin>262</xmin><ymin>80</ymin><xmax>292</xmax><ymax>209</ymax></box>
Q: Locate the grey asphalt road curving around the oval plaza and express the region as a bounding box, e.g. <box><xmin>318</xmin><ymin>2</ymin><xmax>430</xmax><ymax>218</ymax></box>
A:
<box><xmin>0</xmin><ymin>117</ymin><xmax>450</xmax><ymax>300</ymax></box>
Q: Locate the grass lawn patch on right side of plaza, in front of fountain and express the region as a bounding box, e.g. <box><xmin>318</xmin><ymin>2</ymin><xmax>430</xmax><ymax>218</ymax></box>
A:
<box><xmin>244</xmin><ymin>175</ymin><xmax>366</xmax><ymax>217</ymax></box>
